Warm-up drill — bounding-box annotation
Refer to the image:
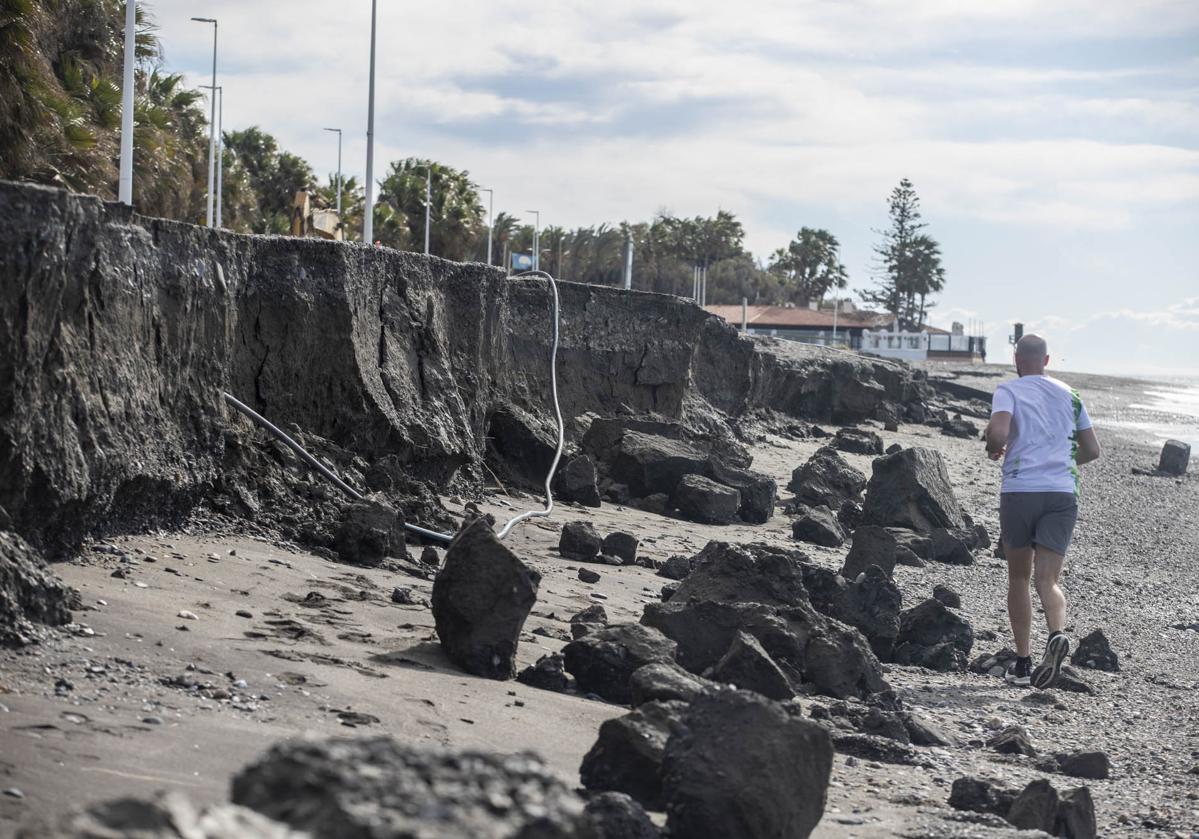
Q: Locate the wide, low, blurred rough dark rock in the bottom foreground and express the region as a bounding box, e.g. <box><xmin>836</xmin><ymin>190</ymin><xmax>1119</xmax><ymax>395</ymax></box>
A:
<box><xmin>231</xmin><ymin>737</ymin><xmax>583</xmax><ymax>839</ymax></box>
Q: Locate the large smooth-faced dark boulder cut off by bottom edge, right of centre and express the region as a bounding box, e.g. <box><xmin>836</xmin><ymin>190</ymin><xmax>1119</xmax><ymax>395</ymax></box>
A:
<box><xmin>662</xmin><ymin>690</ymin><xmax>832</xmax><ymax>839</ymax></box>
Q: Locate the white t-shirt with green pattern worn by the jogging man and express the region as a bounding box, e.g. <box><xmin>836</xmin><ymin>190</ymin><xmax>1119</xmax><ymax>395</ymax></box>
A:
<box><xmin>990</xmin><ymin>375</ymin><xmax>1091</xmax><ymax>495</ymax></box>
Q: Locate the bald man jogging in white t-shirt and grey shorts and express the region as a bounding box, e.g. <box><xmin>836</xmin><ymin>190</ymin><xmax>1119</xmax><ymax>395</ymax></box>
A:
<box><xmin>986</xmin><ymin>333</ymin><xmax>1099</xmax><ymax>688</ymax></box>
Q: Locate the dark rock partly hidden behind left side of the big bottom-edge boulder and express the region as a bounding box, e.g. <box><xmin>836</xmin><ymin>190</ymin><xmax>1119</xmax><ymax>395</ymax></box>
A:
<box><xmin>579</xmin><ymin>702</ymin><xmax>687</xmax><ymax>810</ymax></box>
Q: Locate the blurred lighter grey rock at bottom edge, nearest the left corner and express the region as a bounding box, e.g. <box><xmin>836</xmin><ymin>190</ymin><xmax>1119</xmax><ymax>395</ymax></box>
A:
<box><xmin>17</xmin><ymin>792</ymin><xmax>294</xmax><ymax>839</ymax></box>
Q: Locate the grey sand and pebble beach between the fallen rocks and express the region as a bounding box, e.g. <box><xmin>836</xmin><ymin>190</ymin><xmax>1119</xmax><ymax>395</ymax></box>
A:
<box><xmin>0</xmin><ymin>367</ymin><xmax>1199</xmax><ymax>837</ymax></box>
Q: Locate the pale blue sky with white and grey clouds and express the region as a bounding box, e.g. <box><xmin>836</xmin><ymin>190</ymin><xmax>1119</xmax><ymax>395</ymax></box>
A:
<box><xmin>150</xmin><ymin>0</ymin><xmax>1199</xmax><ymax>375</ymax></box>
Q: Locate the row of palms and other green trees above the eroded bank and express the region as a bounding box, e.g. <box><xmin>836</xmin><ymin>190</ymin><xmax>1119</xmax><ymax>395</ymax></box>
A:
<box><xmin>0</xmin><ymin>0</ymin><xmax>945</xmax><ymax>328</ymax></box>
